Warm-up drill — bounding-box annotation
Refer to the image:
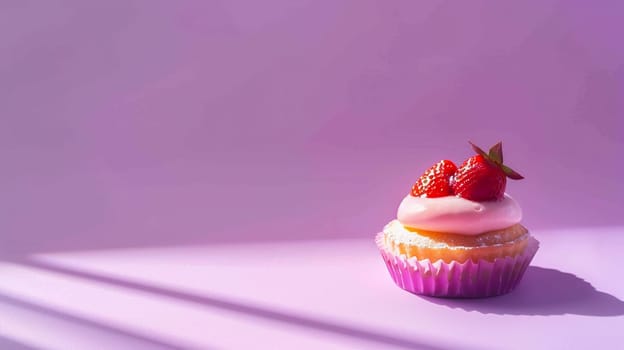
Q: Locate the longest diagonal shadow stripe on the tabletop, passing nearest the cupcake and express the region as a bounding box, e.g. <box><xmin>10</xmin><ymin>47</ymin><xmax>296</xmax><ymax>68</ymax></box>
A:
<box><xmin>18</xmin><ymin>259</ymin><xmax>446</xmax><ymax>350</ymax></box>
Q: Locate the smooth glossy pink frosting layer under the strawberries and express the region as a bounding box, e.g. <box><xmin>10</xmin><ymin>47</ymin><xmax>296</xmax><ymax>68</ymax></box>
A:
<box><xmin>397</xmin><ymin>194</ymin><xmax>522</xmax><ymax>236</ymax></box>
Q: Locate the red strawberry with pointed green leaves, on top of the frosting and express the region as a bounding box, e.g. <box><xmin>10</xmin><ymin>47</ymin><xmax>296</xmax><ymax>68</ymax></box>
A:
<box><xmin>452</xmin><ymin>142</ymin><xmax>523</xmax><ymax>202</ymax></box>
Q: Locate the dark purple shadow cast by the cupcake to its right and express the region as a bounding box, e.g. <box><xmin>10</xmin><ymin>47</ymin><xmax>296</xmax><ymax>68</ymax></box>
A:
<box><xmin>426</xmin><ymin>266</ymin><xmax>624</xmax><ymax>316</ymax></box>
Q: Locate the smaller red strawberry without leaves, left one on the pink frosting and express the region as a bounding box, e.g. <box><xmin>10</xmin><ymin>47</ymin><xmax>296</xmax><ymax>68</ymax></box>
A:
<box><xmin>411</xmin><ymin>160</ymin><xmax>457</xmax><ymax>198</ymax></box>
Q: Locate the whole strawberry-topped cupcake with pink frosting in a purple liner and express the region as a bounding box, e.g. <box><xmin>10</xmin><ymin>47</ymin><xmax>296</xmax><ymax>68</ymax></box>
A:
<box><xmin>376</xmin><ymin>142</ymin><xmax>539</xmax><ymax>298</ymax></box>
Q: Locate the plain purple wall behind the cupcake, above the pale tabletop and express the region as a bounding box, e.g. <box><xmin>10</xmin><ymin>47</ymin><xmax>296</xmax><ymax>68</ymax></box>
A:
<box><xmin>0</xmin><ymin>0</ymin><xmax>624</xmax><ymax>348</ymax></box>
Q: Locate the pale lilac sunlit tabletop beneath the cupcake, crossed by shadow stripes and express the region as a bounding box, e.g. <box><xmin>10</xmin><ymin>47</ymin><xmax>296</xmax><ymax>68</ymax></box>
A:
<box><xmin>0</xmin><ymin>227</ymin><xmax>624</xmax><ymax>349</ymax></box>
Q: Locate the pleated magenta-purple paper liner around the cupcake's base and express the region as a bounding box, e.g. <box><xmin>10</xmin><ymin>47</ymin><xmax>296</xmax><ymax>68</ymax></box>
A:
<box><xmin>375</xmin><ymin>232</ymin><xmax>539</xmax><ymax>298</ymax></box>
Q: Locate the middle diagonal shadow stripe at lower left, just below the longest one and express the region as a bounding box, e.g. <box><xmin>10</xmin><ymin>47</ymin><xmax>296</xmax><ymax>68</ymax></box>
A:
<box><xmin>0</xmin><ymin>293</ymin><xmax>190</xmax><ymax>350</ymax></box>
